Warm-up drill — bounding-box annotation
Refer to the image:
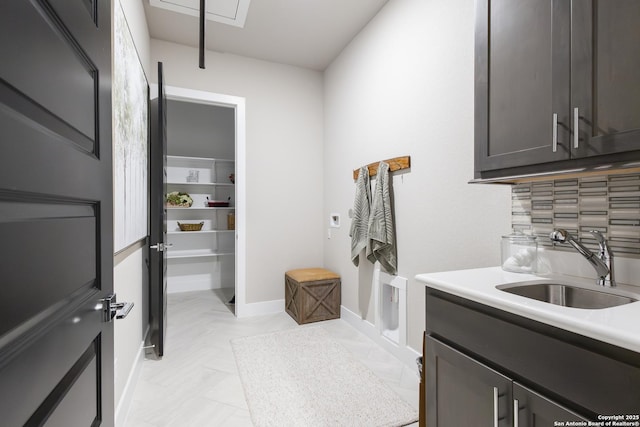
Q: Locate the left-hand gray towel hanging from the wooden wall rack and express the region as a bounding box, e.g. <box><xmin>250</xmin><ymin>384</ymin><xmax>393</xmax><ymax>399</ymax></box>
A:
<box><xmin>349</xmin><ymin>166</ymin><xmax>371</xmax><ymax>267</ymax></box>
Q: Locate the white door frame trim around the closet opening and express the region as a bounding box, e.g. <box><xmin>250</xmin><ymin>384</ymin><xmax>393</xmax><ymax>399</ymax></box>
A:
<box><xmin>162</xmin><ymin>86</ymin><xmax>247</xmax><ymax>317</ymax></box>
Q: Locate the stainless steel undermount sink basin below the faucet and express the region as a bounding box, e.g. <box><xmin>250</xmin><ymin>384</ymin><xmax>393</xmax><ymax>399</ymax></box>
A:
<box><xmin>496</xmin><ymin>282</ymin><xmax>638</xmax><ymax>309</ymax></box>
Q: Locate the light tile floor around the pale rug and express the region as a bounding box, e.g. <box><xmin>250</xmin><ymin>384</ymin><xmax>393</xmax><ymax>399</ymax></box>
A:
<box><xmin>125</xmin><ymin>289</ymin><xmax>420</xmax><ymax>427</ymax></box>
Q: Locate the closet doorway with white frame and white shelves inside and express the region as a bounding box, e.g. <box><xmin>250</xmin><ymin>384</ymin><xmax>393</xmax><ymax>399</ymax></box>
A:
<box><xmin>165</xmin><ymin>86</ymin><xmax>246</xmax><ymax>317</ymax></box>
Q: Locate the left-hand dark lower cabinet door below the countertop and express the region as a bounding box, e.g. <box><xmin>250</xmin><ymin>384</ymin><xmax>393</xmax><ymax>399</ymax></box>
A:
<box><xmin>426</xmin><ymin>336</ymin><xmax>512</xmax><ymax>427</ymax></box>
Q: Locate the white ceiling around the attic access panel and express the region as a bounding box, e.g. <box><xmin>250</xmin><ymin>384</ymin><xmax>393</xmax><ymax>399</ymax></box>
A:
<box><xmin>143</xmin><ymin>0</ymin><xmax>389</xmax><ymax>70</ymax></box>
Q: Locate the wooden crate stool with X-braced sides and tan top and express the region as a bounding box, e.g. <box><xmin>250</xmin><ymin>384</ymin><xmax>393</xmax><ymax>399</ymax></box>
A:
<box><xmin>284</xmin><ymin>268</ymin><xmax>341</xmax><ymax>325</ymax></box>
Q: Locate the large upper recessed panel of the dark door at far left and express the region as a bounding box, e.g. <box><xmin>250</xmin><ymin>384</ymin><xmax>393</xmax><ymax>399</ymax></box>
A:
<box><xmin>0</xmin><ymin>2</ymin><xmax>98</xmax><ymax>145</ymax></box>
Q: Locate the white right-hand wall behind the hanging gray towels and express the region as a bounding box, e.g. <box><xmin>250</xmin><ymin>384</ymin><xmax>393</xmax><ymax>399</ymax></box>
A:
<box><xmin>323</xmin><ymin>0</ymin><xmax>510</xmax><ymax>349</ymax></box>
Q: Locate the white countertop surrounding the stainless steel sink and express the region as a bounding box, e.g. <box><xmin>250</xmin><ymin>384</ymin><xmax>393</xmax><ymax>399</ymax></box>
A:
<box><xmin>416</xmin><ymin>267</ymin><xmax>640</xmax><ymax>352</ymax></box>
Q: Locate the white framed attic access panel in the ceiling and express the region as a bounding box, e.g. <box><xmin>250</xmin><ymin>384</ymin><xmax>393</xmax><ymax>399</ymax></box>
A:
<box><xmin>149</xmin><ymin>0</ymin><xmax>251</xmax><ymax>28</ymax></box>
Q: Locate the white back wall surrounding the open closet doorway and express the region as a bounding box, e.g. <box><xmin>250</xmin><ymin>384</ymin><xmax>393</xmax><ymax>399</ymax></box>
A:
<box><xmin>151</xmin><ymin>39</ymin><xmax>323</xmax><ymax>303</ymax></box>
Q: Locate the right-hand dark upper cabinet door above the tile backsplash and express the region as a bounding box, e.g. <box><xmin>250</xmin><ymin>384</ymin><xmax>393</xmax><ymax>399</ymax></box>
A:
<box><xmin>571</xmin><ymin>0</ymin><xmax>640</xmax><ymax>157</ymax></box>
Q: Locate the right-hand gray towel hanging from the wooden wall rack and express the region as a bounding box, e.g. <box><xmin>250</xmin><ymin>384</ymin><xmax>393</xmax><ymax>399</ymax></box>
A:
<box><xmin>367</xmin><ymin>162</ymin><xmax>398</xmax><ymax>274</ymax></box>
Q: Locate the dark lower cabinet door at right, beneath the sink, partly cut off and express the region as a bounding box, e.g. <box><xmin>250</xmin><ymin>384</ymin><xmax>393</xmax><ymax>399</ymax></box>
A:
<box><xmin>513</xmin><ymin>382</ymin><xmax>588</xmax><ymax>427</ymax></box>
